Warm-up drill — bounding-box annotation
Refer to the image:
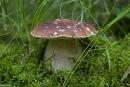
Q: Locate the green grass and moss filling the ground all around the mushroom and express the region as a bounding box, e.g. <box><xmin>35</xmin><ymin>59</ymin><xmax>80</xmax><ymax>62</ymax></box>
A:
<box><xmin>0</xmin><ymin>0</ymin><xmax>130</xmax><ymax>87</ymax></box>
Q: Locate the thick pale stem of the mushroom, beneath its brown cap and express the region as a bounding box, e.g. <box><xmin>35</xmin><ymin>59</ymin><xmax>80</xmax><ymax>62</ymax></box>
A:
<box><xmin>45</xmin><ymin>39</ymin><xmax>82</xmax><ymax>72</ymax></box>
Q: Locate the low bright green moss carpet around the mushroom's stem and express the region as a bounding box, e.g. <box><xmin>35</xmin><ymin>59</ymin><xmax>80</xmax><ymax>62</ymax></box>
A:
<box><xmin>0</xmin><ymin>33</ymin><xmax>130</xmax><ymax>87</ymax></box>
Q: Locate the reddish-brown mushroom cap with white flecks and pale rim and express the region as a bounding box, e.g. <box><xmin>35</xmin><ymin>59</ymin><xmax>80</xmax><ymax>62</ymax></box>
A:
<box><xmin>31</xmin><ymin>19</ymin><xmax>96</xmax><ymax>38</ymax></box>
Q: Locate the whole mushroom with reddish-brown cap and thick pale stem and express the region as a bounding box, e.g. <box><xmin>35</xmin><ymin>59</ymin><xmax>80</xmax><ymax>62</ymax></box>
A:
<box><xmin>31</xmin><ymin>19</ymin><xmax>96</xmax><ymax>72</ymax></box>
